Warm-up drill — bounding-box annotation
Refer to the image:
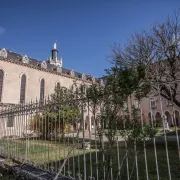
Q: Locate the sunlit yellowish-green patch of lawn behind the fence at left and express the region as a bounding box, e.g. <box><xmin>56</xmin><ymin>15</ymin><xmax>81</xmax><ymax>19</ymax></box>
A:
<box><xmin>0</xmin><ymin>140</ymin><xmax>88</xmax><ymax>164</ymax></box>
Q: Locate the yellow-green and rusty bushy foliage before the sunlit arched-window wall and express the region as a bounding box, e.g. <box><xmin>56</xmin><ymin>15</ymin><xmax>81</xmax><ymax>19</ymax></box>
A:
<box><xmin>30</xmin><ymin>85</ymin><xmax>80</xmax><ymax>137</ymax></box>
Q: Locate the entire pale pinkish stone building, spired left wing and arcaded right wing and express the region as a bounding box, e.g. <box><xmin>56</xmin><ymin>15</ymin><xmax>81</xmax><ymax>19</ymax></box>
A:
<box><xmin>0</xmin><ymin>43</ymin><xmax>180</xmax><ymax>138</ymax></box>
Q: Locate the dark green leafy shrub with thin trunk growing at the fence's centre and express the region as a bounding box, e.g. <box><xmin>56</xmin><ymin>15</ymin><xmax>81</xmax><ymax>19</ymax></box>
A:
<box><xmin>86</xmin><ymin>58</ymin><xmax>156</xmax><ymax>179</ymax></box>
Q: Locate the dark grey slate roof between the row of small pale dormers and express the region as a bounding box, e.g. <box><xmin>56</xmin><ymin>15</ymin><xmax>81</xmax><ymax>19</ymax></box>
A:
<box><xmin>0</xmin><ymin>48</ymin><xmax>91</xmax><ymax>80</ymax></box>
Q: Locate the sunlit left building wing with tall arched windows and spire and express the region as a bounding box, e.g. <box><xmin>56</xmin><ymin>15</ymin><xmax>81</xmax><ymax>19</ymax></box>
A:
<box><xmin>0</xmin><ymin>43</ymin><xmax>102</xmax><ymax>136</ymax></box>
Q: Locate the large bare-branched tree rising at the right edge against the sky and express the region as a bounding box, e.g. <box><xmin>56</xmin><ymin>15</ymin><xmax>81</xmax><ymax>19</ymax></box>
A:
<box><xmin>111</xmin><ymin>13</ymin><xmax>180</xmax><ymax>107</ymax></box>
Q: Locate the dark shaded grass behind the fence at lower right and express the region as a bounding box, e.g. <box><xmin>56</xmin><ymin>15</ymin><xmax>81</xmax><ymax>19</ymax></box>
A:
<box><xmin>66</xmin><ymin>143</ymin><xmax>180</xmax><ymax>180</ymax></box>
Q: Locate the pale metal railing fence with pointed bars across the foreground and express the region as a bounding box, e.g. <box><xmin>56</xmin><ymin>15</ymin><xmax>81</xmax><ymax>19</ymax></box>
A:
<box><xmin>0</xmin><ymin>86</ymin><xmax>180</xmax><ymax>180</ymax></box>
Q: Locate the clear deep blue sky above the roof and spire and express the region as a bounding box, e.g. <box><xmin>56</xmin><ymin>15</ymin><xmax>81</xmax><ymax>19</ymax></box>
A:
<box><xmin>0</xmin><ymin>0</ymin><xmax>180</xmax><ymax>77</ymax></box>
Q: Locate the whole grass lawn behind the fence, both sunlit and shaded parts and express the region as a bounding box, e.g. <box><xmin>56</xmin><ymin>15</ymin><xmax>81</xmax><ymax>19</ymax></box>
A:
<box><xmin>0</xmin><ymin>140</ymin><xmax>180</xmax><ymax>180</ymax></box>
